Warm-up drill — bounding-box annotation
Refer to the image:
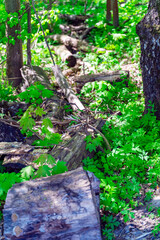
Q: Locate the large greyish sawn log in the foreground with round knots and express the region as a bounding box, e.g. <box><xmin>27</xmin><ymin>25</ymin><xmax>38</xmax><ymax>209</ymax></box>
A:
<box><xmin>3</xmin><ymin>168</ymin><xmax>102</xmax><ymax>240</ymax></box>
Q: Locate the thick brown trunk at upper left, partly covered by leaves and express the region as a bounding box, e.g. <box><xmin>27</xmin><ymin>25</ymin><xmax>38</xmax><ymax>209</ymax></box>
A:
<box><xmin>5</xmin><ymin>0</ymin><xmax>23</xmax><ymax>87</ymax></box>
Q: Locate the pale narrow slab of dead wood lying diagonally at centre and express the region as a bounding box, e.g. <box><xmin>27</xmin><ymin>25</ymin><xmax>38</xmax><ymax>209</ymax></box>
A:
<box><xmin>53</xmin><ymin>65</ymin><xmax>85</xmax><ymax>110</ymax></box>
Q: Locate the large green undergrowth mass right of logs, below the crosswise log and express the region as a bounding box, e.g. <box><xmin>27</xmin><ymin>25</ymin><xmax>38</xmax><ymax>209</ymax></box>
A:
<box><xmin>82</xmin><ymin>77</ymin><xmax>160</xmax><ymax>239</ymax></box>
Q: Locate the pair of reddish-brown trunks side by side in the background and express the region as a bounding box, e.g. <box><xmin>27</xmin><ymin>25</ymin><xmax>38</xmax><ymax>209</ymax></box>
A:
<box><xmin>106</xmin><ymin>0</ymin><xmax>119</xmax><ymax>27</ymax></box>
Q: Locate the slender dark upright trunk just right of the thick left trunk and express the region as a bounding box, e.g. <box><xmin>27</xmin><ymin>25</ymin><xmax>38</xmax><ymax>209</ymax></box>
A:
<box><xmin>26</xmin><ymin>2</ymin><xmax>32</xmax><ymax>66</ymax></box>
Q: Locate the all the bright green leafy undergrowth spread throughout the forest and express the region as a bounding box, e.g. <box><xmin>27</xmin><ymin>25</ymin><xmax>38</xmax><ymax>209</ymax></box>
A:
<box><xmin>0</xmin><ymin>0</ymin><xmax>160</xmax><ymax>240</ymax></box>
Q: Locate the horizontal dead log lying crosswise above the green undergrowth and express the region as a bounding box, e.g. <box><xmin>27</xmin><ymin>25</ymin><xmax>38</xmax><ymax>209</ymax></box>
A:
<box><xmin>74</xmin><ymin>71</ymin><xmax>129</xmax><ymax>93</ymax></box>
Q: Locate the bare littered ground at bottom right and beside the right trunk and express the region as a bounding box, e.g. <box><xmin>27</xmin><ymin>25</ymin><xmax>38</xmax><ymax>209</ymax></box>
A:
<box><xmin>105</xmin><ymin>63</ymin><xmax>160</xmax><ymax>240</ymax></box>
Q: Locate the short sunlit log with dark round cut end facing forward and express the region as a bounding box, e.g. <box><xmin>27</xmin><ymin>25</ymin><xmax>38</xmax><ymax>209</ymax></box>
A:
<box><xmin>53</xmin><ymin>45</ymin><xmax>77</xmax><ymax>67</ymax></box>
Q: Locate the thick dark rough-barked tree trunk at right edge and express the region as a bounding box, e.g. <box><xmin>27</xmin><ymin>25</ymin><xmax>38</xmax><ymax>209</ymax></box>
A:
<box><xmin>137</xmin><ymin>0</ymin><xmax>160</xmax><ymax>119</ymax></box>
